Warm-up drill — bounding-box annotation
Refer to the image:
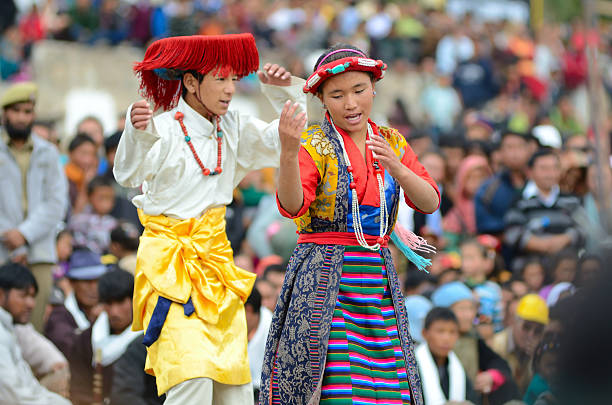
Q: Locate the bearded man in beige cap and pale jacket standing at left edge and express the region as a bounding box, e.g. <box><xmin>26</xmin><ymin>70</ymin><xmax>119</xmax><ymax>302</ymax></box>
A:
<box><xmin>0</xmin><ymin>83</ymin><xmax>67</xmax><ymax>331</ymax></box>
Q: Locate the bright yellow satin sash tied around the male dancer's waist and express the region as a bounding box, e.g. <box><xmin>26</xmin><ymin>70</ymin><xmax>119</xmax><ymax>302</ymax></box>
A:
<box><xmin>132</xmin><ymin>207</ymin><xmax>256</xmax><ymax>330</ymax></box>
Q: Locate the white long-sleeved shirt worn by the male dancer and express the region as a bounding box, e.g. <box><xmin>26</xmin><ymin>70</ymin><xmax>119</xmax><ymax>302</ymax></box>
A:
<box><xmin>113</xmin><ymin>77</ymin><xmax>306</xmax><ymax>219</ymax></box>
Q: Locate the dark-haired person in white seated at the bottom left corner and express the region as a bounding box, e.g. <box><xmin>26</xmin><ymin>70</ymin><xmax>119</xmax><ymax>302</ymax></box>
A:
<box><xmin>0</xmin><ymin>263</ymin><xmax>70</xmax><ymax>405</ymax></box>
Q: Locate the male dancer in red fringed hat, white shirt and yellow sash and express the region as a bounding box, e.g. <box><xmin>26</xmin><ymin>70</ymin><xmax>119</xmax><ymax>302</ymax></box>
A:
<box><xmin>114</xmin><ymin>34</ymin><xmax>306</xmax><ymax>404</ymax></box>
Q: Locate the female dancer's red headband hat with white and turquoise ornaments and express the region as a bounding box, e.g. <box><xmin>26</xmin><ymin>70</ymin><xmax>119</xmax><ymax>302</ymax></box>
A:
<box><xmin>304</xmin><ymin>54</ymin><xmax>387</xmax><ymax>94</ymax></box>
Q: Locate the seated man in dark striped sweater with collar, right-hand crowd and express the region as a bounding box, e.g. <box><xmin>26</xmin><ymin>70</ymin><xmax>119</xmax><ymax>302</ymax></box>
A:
<box><xmin>505</xmin><ymin>149</ymin><xmax>584</xmax><ymax>269</ymax></box>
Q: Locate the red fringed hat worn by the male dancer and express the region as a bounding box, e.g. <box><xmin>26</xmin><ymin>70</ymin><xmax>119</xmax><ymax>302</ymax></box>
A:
<box><xmin>134</xmin><ymin>34</ymin><xmax>259</xmax><ymax>110</ymax></box>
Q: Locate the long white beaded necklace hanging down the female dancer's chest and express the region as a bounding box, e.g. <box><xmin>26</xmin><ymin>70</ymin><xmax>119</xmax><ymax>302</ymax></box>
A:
<box><xmin>330</xmin><ymin>117</ymin><xmax>388</xmax><ymax>251</ymax></box>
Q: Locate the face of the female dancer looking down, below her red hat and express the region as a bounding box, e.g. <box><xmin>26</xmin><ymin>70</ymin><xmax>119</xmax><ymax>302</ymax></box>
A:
<box><xmin>319</xmin><ymin>71</ymin><xmax>374</xmax><ymax>136</ymax></box>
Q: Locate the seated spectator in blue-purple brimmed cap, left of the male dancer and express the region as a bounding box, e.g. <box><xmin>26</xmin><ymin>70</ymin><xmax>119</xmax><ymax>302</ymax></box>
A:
<box><xmin>45</xmin><ymin>250</ymin><xmax>106</xmax><ymax>358</ymax></box>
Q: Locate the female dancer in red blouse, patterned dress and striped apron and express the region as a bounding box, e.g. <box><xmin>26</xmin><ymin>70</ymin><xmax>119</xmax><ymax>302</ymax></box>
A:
<box><xmin>260</xmin><ymin>45</ymin><xmax>440</xmax><ymax>404</ymax></box>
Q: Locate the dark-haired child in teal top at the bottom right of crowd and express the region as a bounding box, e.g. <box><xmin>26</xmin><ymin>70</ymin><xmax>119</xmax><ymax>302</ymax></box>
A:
<box><xmin>523</xmin><ymin>333</ymin><xmax>559</xmax><ymax>405</ymax></box>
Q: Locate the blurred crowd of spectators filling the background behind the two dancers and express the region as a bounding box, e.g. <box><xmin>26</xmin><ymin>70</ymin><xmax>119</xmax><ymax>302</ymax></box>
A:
<box><xmin>0</xmin><ymin>0</ymin><xmax>612</xmax><ymax>405</ymax></box>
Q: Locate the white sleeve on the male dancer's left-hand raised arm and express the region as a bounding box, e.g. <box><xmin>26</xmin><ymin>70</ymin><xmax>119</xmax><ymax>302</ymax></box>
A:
<box><xmin>113</xmin><ymin>104</ymin><xmax>168</xmax><ymax>187</ymax></box>
